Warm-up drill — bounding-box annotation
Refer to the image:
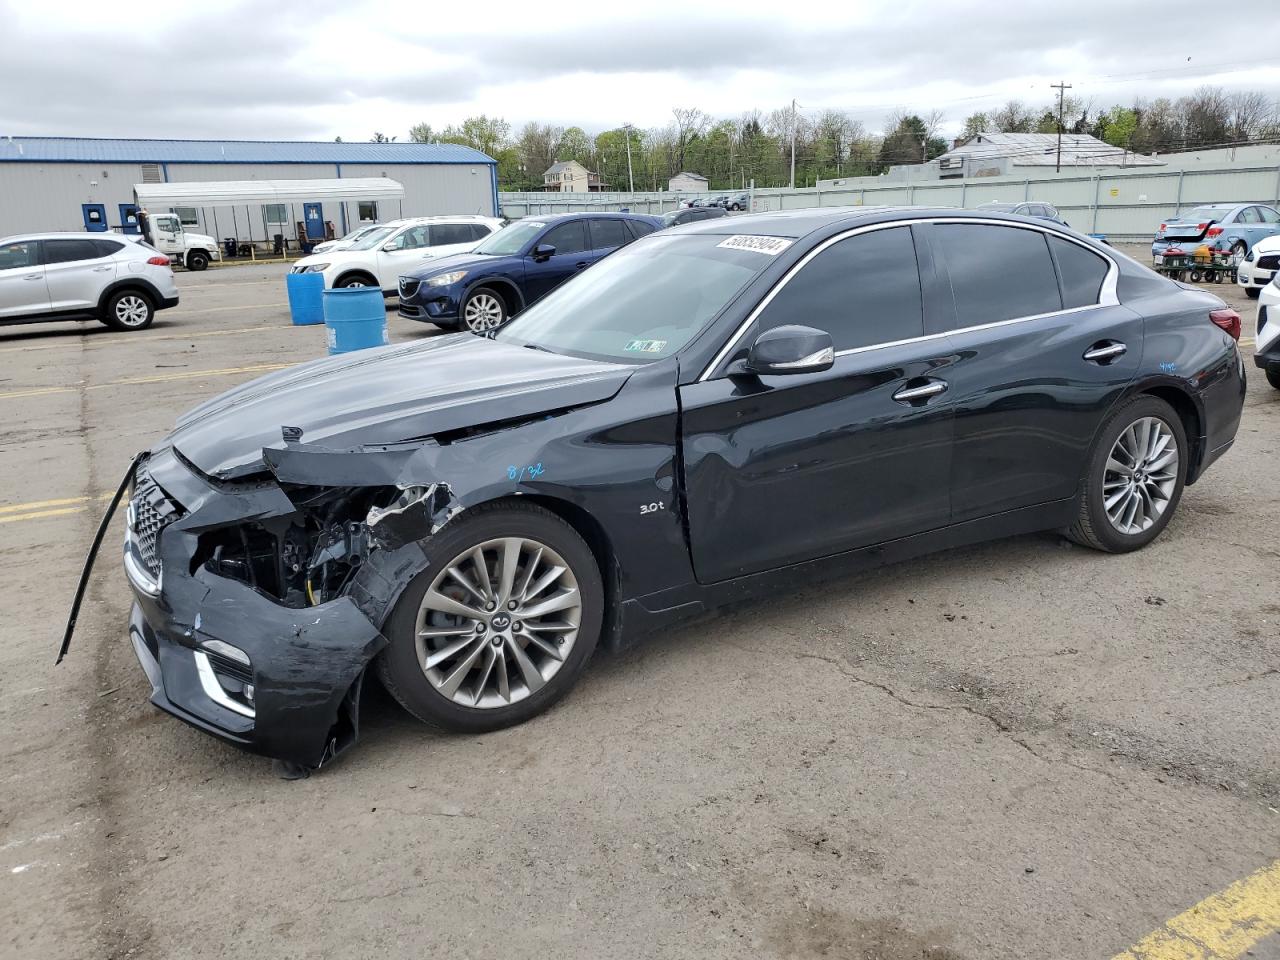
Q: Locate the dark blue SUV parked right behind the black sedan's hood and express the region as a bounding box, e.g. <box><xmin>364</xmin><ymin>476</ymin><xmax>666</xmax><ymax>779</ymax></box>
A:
<box><xmin>399</xmin><ymin>214</ymin><xmax>663</xmax><ymax>333</ymax></box>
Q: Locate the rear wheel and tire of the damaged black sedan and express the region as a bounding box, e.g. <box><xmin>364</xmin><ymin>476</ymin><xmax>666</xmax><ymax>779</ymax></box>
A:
<box><xmin>1068</xmin><ymin>394</ymin><xmax>1188</xmax><ymax>553</ymax></box>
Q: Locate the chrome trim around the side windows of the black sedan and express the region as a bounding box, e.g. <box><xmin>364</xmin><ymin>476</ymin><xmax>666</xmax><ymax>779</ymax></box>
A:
<box><xmin>694</xmin><ymin>216</ymin><xmax>1120</xmax><ymax>383</ymax></box>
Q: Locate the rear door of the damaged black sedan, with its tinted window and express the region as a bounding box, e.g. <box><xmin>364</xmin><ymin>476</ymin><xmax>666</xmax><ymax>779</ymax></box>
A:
<box><xmin>929</xmin><ymin>221</ymin><xmax>1143</xmax><ymax>522</ymax></box>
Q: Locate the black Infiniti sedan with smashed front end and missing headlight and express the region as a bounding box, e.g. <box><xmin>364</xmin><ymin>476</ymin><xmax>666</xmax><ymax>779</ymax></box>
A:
<box><xmin>68</xmin><ymin>209</ymin><xmax>1244</xmax><ymax>773</ymax></box>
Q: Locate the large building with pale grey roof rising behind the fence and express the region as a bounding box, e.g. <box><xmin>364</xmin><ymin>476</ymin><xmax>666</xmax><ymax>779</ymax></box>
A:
<box><xmin>925</xmin><ymin>133</ymin><xmax>1165</xmax><ymax>180</ymax></box>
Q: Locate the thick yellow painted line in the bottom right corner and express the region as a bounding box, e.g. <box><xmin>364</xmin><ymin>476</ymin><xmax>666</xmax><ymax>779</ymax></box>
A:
<box><xmin>1112</xmin><ymin>860</ymin><xmax>1280</xmax><ymax>960</ymax></box>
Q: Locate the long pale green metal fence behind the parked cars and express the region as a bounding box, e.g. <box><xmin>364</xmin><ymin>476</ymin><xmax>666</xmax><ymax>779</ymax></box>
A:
<box><xmin>499</xmin><ymin>164</ymin><xmax>1280</xmax><ymax>241</ymax></box>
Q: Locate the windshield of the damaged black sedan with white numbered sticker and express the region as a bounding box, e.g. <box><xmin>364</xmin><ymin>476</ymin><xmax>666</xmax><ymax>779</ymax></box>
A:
<box><xmin>495</xmin><ymin>234</ymin><xmax>773</xmax><ymax>364</ymax></box>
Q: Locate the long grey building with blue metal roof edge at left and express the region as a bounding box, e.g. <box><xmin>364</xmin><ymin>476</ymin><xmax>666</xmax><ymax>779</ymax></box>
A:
<box><xmin>0</xmin><ymin>136</ymin><xmax>498</xmax><ymax>242</ymax></box>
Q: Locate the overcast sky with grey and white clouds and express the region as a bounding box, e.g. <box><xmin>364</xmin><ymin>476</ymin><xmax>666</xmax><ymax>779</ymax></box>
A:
<box><xmin>0</xmin><ymin>0</ymin><xmax>1280</xmax><ymax>140</ymax></box>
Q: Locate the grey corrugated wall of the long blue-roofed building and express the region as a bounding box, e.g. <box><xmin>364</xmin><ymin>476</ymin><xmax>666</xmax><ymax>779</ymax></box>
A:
<box><xmin>0</xmin><ymin>163</ymin><xmax>494</xmax><ymax>241</ymax></box>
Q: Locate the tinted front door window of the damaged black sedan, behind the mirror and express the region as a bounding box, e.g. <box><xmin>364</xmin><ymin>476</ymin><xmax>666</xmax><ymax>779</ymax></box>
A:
<box><xmin>756</xmin><ymin>227</ymin><xmax>926</xmax><ymax>349</ymax></box>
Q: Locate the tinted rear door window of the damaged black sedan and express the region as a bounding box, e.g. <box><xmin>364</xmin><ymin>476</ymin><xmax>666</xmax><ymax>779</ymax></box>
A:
<box><xmin>933</xmin><ymin>223</ymin><xmax>1062</xmax><ymax>326</ymax></box>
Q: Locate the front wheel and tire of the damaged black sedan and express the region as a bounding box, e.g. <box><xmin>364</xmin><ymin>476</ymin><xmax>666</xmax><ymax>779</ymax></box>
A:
<box><xmin>378</xmin><ymin>503</ymin><xmax>604</xmax><ymax>733</ymax></box>
